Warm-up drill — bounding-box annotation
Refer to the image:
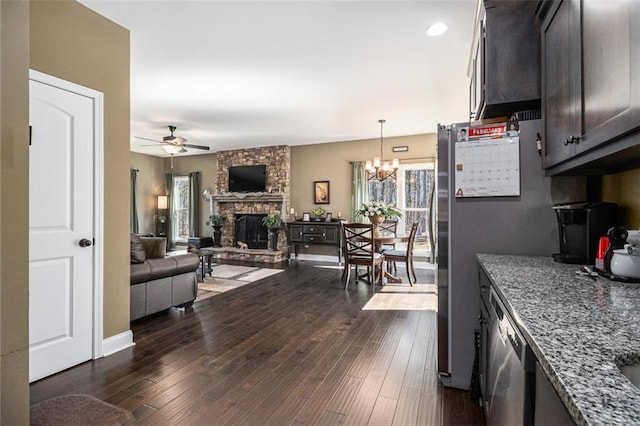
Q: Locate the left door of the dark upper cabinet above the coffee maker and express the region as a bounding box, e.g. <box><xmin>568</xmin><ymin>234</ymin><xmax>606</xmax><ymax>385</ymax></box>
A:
<box><xmin>541</xmin><ymin>0</ymin><xmax>582</xmax><ymax>167</ymax></box>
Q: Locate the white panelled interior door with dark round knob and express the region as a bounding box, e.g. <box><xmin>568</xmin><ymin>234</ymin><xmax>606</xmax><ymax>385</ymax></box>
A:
<box><xmin>29</xmin><ymin>74</ymin><xmax>95</xmax><ymax>381</ymax></box>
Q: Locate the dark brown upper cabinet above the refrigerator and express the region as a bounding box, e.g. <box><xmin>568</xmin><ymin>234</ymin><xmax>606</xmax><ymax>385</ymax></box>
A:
<box><xmin>469</xmin><ymin>0</ymin><xmax>540</xmax><ymax>120</ymax></box>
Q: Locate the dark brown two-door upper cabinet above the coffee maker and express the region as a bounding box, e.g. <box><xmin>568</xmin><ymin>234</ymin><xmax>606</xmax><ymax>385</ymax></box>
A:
<box><xmin>538</xmin><ymin>0</ymin><xmax>640</xmax><ymax>175</ymax></box>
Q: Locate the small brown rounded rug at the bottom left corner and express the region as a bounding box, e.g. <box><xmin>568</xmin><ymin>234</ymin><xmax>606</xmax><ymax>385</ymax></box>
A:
<box><xmin>29</xmin><ymin>395</ymin><xmax>136</xmax><ymax>425</ymax></box>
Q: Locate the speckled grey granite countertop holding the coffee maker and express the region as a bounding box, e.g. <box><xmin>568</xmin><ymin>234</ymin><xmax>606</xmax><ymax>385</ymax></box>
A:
<box><xmin>478</xmin><ymin>254</ymin><xmax>640</xmax><ymax>425</ymax></box>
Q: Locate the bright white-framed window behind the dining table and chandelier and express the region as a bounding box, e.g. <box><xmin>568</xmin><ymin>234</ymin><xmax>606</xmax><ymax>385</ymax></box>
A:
<box><xmin>369</xmin><ymin>163</ymin><xmax>435</xmax><ymax>256</ymax></box>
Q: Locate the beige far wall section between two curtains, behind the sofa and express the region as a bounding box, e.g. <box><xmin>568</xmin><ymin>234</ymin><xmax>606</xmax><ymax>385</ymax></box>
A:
<box><xmin>129</xmin><ymin>152</ymin><xmax>166</xmax><ymax>234</ymax></box>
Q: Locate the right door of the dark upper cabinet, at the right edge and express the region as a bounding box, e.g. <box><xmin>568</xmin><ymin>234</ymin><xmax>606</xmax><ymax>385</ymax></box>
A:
<box><xmin>576</xmin><ymin>0</ymin><xmax>640</xmax><ymax>152</ymax></box>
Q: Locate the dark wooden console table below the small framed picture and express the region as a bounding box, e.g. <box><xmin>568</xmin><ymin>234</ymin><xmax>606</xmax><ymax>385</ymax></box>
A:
<box><xmin>287</xmin><ymin>220</ymin><xmax>342</xmax><ymax>263</ymax></box>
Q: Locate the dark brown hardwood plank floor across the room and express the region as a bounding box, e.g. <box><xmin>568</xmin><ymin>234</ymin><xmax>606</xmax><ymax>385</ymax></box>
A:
<box><xmin>31</xmin><ymin>261</ymin><xmax>484</xmax><ymax>425</ymax></box>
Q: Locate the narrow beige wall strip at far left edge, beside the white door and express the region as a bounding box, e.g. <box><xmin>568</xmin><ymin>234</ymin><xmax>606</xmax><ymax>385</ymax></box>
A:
<box><xmin>0</xmin><ymin>1</ymin><xmax>29</xmax><ymax>425</ymax></box>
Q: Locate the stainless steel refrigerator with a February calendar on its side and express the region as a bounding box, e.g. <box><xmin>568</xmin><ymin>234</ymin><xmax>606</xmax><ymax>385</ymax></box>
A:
<box><xmin>436</xmin><ymin>119</ymin><xmax>558</xmax><ymax>389</ymax></box>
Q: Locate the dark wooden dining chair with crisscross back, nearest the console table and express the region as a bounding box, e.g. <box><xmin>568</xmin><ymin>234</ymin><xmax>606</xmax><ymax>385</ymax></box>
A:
<box><xmin>342</xmin><ymin>223</ymin><xmax>384</xmax><ymax>289</ymax></box>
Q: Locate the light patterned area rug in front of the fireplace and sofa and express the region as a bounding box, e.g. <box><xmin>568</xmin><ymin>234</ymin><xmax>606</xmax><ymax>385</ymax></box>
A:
<box><xmin>195</xmin><ymin>264</ymin><xmax>283</xmax><ymax>303</ymax></box>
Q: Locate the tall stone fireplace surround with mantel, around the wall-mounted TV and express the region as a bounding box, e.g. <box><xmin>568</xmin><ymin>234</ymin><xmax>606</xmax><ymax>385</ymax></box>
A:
<box><xmin>213</xmin><ymin>145</ymin><xmax>291</xmax><ymax>250</ymax></box>
